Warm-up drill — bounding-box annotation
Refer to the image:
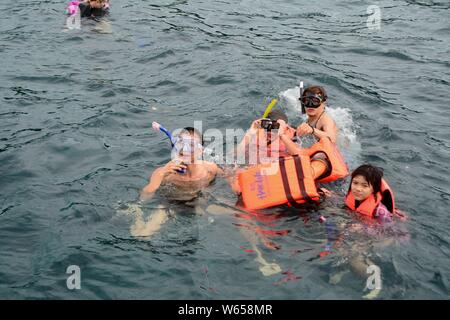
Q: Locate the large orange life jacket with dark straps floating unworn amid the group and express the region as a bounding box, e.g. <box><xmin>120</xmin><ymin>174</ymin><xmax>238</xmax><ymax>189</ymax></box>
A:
<box><xmin>238</xmin><ymin>138</ymin><xmax>348</xmax><ymax>209</ymax></box>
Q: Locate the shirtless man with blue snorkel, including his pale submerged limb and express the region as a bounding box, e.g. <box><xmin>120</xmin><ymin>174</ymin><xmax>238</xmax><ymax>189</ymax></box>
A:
<box><xmin>125</xmin><ymin>127</ymin><xmax>222</xmax><ymax>237</ymax></box>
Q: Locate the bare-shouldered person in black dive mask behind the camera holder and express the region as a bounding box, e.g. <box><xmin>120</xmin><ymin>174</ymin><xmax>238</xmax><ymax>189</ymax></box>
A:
<box><xmin>297</xmin><ymin>86</ymin><xmax>338</xmax><ymax>143</ymax></box>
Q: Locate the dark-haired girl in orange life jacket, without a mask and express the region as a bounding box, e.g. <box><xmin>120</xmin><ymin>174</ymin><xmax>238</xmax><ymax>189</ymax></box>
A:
<box><xmin>345</xmin><ymin>164</ymin><xmax>401</xmax><ymax>222</ymax></box>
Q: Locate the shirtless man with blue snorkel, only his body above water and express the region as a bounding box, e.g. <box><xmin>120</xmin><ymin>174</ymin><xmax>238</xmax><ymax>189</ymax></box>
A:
<box><xmin>140</xmin><ymin>127</ymin><xmax>220</xmax><ymax>201</ymax></box>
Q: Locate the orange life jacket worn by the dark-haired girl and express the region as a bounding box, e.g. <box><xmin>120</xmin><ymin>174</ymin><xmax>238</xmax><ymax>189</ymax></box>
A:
<box><xmin>345</xmin><ymin>179</ymin><xmax>395</xmax><ymax>218</ymax></box>
